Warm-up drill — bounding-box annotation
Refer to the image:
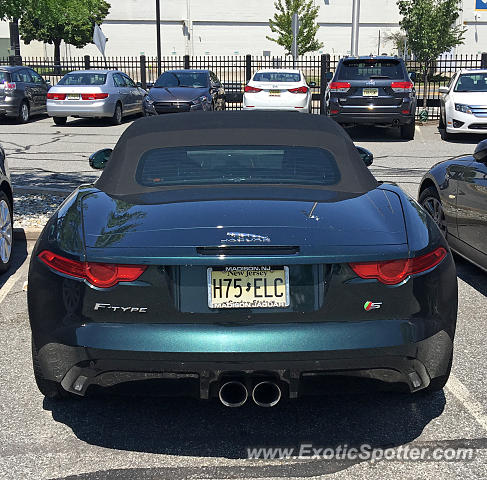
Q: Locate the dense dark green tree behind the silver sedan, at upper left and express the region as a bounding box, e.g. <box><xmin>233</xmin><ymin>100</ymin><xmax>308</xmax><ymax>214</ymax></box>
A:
<box><xmin>20</xmin><ymin>0</ymin><xmax>110</xmax><ymax>70</ymax></box>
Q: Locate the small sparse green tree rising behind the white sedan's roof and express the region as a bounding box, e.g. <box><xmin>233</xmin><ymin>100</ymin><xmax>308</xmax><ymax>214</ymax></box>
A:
<box><xmin>266</xmin><ymin>0</ymin><xmax>323</xmax><ymax>55</ymax></box>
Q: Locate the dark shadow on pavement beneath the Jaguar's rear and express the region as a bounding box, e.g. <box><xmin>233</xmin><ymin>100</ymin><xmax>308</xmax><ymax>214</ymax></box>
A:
<box><xmin>44</xmin><ymin>382</ymin><xmax>445</xmax><ymax>478</ymax></box>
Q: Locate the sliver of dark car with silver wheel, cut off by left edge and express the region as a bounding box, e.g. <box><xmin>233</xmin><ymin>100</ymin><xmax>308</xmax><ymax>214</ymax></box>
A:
<box><xmin>0</xmin><ymin>146</ymin><xmax>14</xmax><ymax>274</ymax></box>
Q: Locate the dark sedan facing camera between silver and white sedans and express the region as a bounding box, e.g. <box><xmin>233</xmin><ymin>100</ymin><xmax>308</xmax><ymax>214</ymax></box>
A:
<box><xmin>144</xmin><ymin>70</ymin><xmax>226</xmax><ymax>115</ymax></box>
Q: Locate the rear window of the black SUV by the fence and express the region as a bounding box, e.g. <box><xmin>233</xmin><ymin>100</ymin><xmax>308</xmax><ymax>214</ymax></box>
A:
<box><xmin>338</xmin><ymin>59</ymin><xmax>404</xmax><ymax>80</ymax></box>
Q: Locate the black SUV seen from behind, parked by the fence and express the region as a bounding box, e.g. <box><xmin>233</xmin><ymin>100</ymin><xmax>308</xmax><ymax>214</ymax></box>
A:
<box><xmin>325</xmin><ymin>56</ymin><xmax>416</xmax><ymax>140</ymax></box>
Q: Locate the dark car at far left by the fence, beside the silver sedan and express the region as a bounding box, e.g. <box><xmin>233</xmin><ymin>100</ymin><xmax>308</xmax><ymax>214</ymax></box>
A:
<box><xmin>0</xmin><ymin>67</ymin><xmax>50</xmax><ymax>123</ymax></box>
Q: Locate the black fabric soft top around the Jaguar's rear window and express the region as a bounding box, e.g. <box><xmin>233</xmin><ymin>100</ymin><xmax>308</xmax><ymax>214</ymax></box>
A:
<box><xmin>95</xmin><ymin>111</ymin><xmax>377</xmax><ymax>196</ymax></box>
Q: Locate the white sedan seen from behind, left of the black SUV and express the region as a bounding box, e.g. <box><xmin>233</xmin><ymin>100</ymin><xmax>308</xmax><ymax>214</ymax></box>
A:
<box><xmin>243</xmin><ymin>69</ymin><xmax>315</xmax><ymax>113</ymax></box>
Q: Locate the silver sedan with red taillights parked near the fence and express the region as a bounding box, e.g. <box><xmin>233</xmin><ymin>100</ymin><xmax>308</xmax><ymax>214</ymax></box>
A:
<box><xmin>47</xmin><ymin>70</ymin><xmax>147</xmax><ymax>125</ymax></box>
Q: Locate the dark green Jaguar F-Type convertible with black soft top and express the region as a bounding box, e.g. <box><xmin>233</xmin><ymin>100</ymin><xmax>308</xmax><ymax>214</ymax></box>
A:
<box><xmin>28</xmin><ymin>112</ymin><xmax>457</xmax><ymax>407</ymax></box>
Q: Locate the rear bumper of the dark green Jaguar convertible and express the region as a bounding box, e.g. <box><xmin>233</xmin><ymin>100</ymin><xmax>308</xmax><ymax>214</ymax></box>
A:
<box><xmin>36</xmin><ymin>319</ymin><xmax>453</xmax><ymax>398</ymax></box>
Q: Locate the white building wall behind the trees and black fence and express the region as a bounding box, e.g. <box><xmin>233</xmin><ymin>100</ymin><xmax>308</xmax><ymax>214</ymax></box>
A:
<box><xmin>0</xmin><ymin>0</ymin><xmax>487</xmax><ymax>57</ymax></box>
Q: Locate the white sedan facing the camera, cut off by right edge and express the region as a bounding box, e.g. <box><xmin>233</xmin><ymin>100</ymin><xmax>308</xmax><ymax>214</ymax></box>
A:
<box><xmin>439</xmin><ymin>70</ymin><xmax>487</xmax><ymax>140</ymax></box>
